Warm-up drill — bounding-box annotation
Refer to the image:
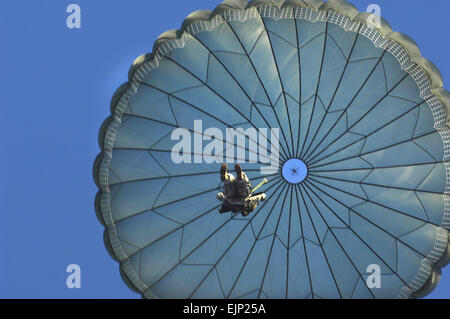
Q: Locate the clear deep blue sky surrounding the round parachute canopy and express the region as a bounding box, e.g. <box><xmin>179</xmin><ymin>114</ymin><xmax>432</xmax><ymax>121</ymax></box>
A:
<box><xmin>0</xmin><ymin>0</ymin><xmax>450</xmax><ymax>298</ymax></box>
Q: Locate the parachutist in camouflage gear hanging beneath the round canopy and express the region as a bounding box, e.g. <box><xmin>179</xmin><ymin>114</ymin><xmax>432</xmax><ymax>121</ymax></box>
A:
<box><xmin>217</xmin><ymin>164</ymin><xmax>267</xmax><ymax>217</ymax></box>
